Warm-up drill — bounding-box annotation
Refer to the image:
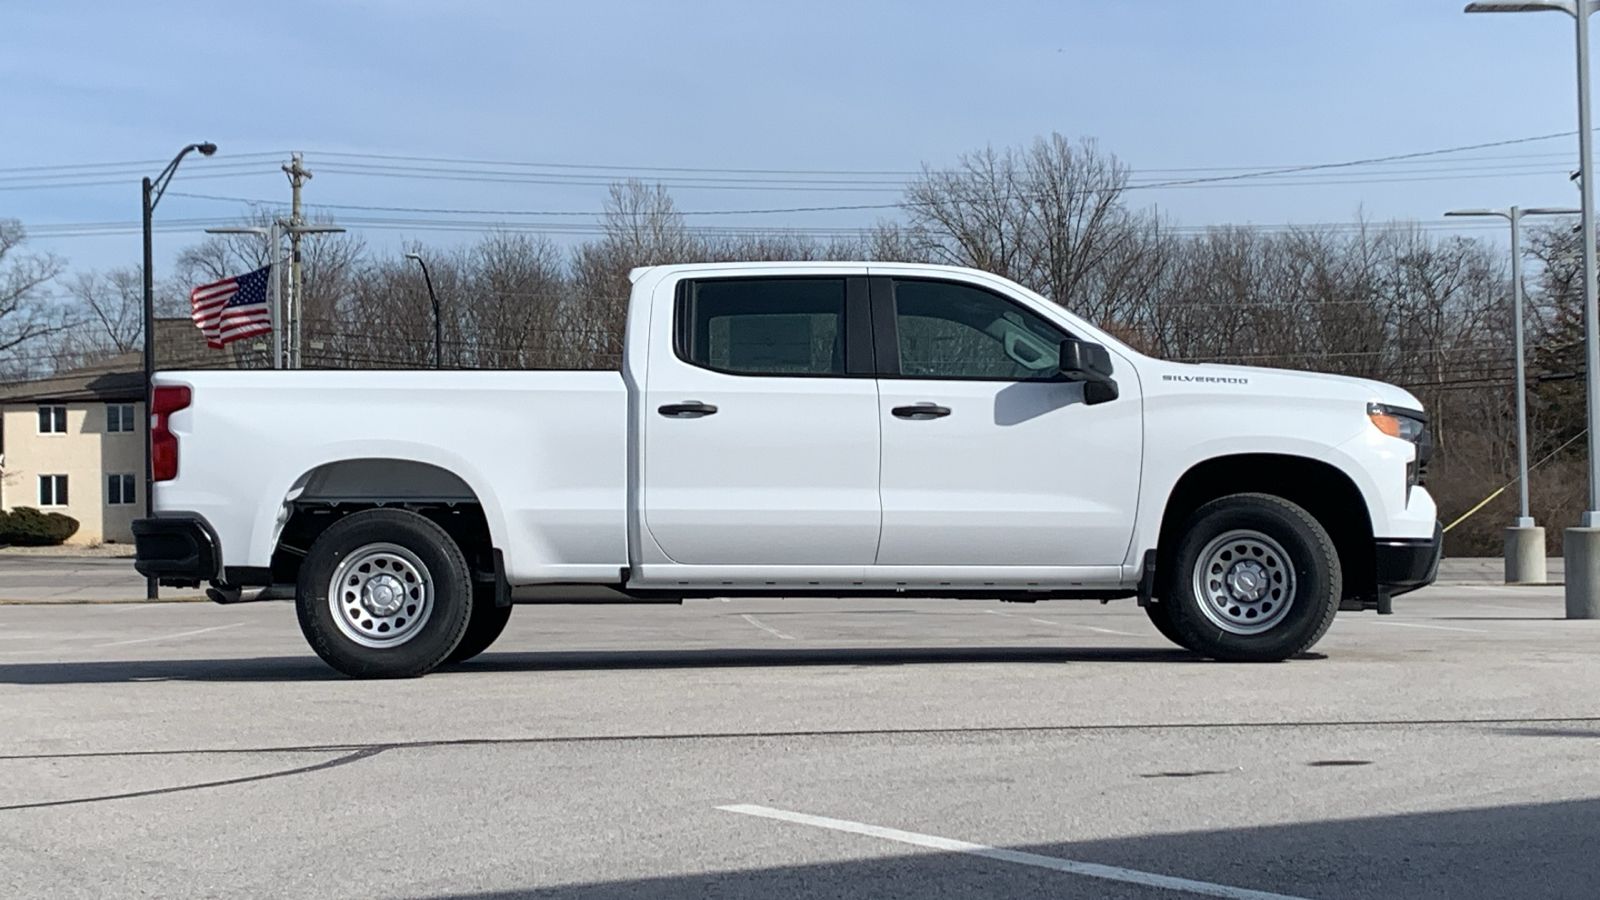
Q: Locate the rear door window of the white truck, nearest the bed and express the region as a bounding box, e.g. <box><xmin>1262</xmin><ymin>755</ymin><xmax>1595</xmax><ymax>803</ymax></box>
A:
<box><xmin>677</xmin><ymin>279</ymin><xmax>845</xmax><ymax>375</ymax></box>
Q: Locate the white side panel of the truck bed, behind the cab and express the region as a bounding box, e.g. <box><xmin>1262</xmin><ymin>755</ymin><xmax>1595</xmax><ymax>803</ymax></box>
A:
<box><xmin>155</xmin><ymin>370</ymin><xmax>627</xmax><ymax>583</ymax></box>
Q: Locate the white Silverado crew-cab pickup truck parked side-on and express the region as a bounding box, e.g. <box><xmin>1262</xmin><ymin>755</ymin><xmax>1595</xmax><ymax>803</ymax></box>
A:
<box><xmin>134</xmin><ymin>263</ymin><xmax>1440</xmax><ymax>676</ymax></box>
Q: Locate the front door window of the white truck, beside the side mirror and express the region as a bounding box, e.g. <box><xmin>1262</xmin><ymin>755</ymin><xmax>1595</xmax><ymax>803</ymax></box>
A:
<box><xmin>894</xmin><ymin>280</ymin><xmax>1066</xmax><ymax>381</ymax></box>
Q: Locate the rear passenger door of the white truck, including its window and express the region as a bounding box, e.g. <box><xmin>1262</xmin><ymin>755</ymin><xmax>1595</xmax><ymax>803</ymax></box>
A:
<box><xmin>642</xmin><ymin>275</ymin><xmax>882</xmax><ymax>567</ymax></box>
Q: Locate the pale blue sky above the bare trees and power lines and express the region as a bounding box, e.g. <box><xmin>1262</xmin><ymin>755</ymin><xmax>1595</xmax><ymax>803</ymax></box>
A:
<box><xmin>0</xmin><ymin>0</ymin><xmax>1576</xmax><ymax>267</ymax></box>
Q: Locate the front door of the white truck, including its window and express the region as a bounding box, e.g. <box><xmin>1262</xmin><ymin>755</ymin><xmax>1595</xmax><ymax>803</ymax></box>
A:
<box><xmin>872</xmin><ymin>277</ymin><xmax>1142</xmax><ymax>567</ymax></box>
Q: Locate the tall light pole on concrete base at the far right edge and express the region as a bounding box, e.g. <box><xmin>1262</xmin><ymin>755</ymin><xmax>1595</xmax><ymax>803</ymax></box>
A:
<box><xmin>1467</xmin><ymin>0</ymin><xmax>1600</xmax><ymax>618</ymax></box>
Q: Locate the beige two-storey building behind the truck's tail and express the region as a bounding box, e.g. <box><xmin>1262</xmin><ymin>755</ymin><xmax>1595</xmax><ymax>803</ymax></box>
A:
<box><xmin>0</xmin><ymin>354</ymin><xmax>147</xmax><ymax>544</ymax></box>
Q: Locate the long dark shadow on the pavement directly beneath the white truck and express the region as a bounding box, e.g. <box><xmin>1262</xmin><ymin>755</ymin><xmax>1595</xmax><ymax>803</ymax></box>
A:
<box><xmin>0</xmin><ymin>647</ymin><xmax>1203</xmax><ymax>684</ymax></box>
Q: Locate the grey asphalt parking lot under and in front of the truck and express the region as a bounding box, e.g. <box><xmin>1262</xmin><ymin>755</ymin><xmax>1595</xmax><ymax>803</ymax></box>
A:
<box><xmin>0</xmin><ymin>560</ymin><xmax>1600</xmax><ymax>900</ymax></box>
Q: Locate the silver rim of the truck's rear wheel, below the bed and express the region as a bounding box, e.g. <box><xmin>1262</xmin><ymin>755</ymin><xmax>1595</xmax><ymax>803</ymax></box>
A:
<box><xmin>328</xmin><ymin>544</ymin><xmax>434</xmax><ymax>649</ymax></box>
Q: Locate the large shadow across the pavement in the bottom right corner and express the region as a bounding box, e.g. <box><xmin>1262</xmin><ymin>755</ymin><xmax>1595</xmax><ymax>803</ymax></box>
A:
<box><xmin>413</xmin><ymin>799</ymin><xmax>1600</xmax><ymax>900</ymax></box>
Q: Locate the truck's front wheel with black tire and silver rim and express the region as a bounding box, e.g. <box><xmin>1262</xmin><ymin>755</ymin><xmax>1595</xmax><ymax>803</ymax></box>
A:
<box><xmin>1162</xmin><ymin>493</ymin><xmax>1342</xmax><ymax>663</ymax></box>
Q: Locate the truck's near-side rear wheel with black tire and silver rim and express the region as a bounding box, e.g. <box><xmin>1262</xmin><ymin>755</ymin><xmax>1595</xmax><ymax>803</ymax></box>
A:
<box><xmin>294</xmin><ymin>509</ymin><xmax>474</xmax><ymax>677</ymax></box>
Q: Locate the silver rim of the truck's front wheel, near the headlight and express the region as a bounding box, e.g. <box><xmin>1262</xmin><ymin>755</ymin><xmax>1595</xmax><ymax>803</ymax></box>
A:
<box><xmin>1194</xmin><ymin>528</ymin><xmax>1294</xmax><ymax>634</ymax></box>
